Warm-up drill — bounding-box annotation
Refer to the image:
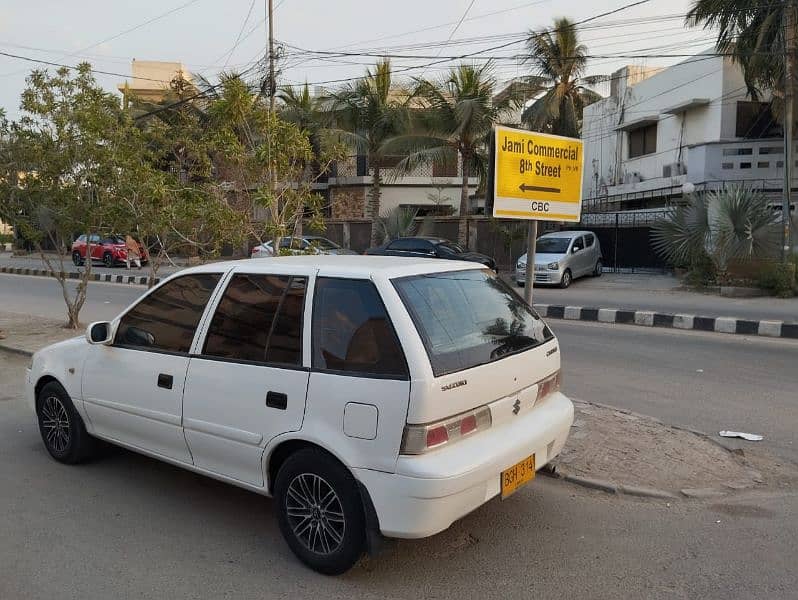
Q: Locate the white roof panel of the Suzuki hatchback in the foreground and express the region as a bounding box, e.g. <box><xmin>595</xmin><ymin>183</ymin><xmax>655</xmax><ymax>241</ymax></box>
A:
<box><xmin>178</xmin><ymin>254</ymin><xmax>485</xmax><ymax>279</ymax></box>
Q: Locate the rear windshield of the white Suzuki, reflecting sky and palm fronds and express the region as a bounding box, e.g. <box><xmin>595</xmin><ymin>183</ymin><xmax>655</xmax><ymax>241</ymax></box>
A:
<box><xmin>393</xmin><ymin>270</ymin><xmax>553</xmax><ymax>377</ymax></box>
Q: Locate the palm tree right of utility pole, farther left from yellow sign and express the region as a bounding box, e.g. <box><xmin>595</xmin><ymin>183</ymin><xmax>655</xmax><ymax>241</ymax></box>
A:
<box><xmin>327</xmin><ymin>59</ymin><xmax>407</xmax><ymax>246</ymax></box>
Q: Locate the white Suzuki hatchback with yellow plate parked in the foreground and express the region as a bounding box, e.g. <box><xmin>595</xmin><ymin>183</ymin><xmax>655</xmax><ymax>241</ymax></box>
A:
<box><xmin>27</xmin><ymin>256</ymin><xmax>573</xmax><ymax>574</ymax></box>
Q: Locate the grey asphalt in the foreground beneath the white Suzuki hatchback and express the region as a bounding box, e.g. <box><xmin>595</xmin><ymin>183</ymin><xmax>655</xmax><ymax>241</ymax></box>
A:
<box><xmin>0</xmin><ymin>355</ymin><xmax>798</xmax><ymax>600</ymax></box>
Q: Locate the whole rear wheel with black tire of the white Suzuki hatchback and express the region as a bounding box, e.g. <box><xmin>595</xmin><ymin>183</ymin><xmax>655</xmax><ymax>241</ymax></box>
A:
<box><xmin>274</xmin><ymin>448</ymin><xmax>366</xmax><ymax>575</ymax></box>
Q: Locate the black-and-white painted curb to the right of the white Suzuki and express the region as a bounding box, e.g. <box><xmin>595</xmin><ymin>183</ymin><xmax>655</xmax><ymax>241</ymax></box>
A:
<box><xmin>535</xmin><ymin>304</ymin><xmax>798</xmax><ymax>339</ymax></box>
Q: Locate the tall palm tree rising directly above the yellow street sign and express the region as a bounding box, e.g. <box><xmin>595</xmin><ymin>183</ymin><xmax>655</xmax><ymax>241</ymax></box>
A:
<box><xmin>521</xmin><ymin>17</ymin><xmax>606</xmax><ymax>137</ymax></box>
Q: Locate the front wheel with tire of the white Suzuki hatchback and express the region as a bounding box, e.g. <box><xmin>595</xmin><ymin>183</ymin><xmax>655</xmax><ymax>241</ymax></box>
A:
<box><xmin>36</xmin><ymin>381</ymin><xmax>94</xmax><ymax>465</ymax></box>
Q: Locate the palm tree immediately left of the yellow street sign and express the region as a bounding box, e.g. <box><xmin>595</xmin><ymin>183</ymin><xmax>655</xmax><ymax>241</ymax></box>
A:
<box><xmin>387</xmin><ymin>64</ymin><xmax>512</xmax><ymax>245</ymax></box>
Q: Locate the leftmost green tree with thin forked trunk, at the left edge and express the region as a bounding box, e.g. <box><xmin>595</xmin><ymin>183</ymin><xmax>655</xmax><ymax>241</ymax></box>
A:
<box><xmin>0</xmin><ymin>63</ymin><xmax>132</xmax><ymax>328</ymax></box>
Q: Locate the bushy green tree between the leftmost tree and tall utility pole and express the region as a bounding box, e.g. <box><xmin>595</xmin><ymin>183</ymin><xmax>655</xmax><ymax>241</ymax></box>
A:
<box><xmin>120</xmin><ymin>78</ymin><xmax>244</xmax><ymax>286</ymax></box>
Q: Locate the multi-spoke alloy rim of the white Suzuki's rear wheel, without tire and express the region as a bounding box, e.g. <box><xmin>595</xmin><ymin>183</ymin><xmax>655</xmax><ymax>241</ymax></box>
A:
<box><xmin>285</xmin><ymin>473</ymin><xmax>346</xmax><ymax>555</ymax></box>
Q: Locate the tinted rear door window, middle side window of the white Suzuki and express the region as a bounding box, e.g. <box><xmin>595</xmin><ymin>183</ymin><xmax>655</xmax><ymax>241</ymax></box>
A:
<box><xmin>203</xmin><ymin>274</ymin><xmax>306</xmax><ymax>366</ymax></box>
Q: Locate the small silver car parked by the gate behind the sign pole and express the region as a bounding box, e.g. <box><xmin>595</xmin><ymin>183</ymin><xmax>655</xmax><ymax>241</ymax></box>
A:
<box><xmin>515</xmin><ymin>231</ymin><xmax>603</xmax><ymax>288</ymax></box>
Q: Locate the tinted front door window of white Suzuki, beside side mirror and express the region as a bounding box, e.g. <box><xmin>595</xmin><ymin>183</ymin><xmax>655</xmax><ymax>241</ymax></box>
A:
<box><xmin>114</xmin><ymin>273</ymin><xmax>221</xmax><ymax>352</ymax></box>
